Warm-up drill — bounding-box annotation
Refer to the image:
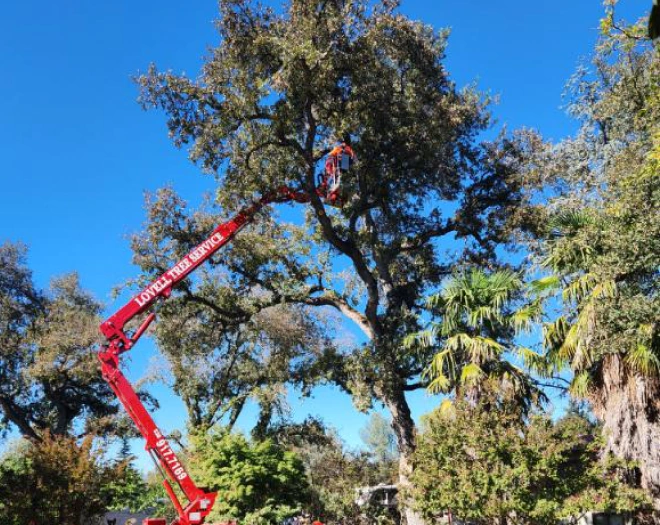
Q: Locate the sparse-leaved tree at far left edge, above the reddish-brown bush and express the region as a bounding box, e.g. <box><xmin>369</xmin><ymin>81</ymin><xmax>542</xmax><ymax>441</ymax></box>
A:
<box><xmin>0</xmin><ymin>242</ymin><xmax>117</xmax><ymax>440</ymax></box>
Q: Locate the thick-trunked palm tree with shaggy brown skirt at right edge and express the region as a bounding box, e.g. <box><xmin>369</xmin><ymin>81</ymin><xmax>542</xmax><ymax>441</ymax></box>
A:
<box><xmin>535</xmin><ymin>204</ymin><xmax>660</xmax><ymax>498</ymax></box>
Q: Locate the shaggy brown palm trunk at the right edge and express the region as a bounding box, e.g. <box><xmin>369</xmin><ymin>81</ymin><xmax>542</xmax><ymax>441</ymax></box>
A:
<box><xmin>590</xmin><ymin>354</ymin><xmax>660</xmax><ymax>509</ymax></box>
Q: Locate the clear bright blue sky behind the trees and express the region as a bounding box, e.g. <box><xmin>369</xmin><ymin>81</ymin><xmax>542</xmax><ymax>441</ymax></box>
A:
<box><xmin>0</xmin><ymin>0</ymin><xmax>651</xmax><ymax>462</ymax></box>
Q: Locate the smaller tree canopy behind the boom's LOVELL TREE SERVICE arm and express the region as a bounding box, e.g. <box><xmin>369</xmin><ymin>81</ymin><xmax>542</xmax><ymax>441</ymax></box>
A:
<box><xmin>132</xmin><ymin>189</ymin><xmax>334</xmax><ymax>437</ymax></box>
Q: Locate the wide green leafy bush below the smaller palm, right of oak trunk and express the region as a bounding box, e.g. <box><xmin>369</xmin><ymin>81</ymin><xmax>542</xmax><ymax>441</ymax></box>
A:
<box><xmin>412</xmin><ymin>400</ymin><xmax>649</xmax><ymax>524</ymax></box>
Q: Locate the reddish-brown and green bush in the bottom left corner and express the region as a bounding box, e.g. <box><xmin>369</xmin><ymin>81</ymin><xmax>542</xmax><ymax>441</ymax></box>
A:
<box><xmin>0</xmin><ymin>432</ymin><xmax>144</xmax><ymax>525</ymax></box>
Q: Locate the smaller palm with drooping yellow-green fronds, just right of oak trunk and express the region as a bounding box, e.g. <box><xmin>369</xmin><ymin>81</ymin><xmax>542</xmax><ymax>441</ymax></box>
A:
<box><xmin>406</xmin><ymin>269</ymin><xmax>544</xmax><ymax>411</ymax></box>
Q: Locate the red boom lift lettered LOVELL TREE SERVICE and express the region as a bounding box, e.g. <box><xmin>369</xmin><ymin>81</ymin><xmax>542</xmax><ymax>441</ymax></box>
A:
<box><xmin>99</xmin><ymin>144</ymin><xmax>355</xmax><ymax>525</ymax></box>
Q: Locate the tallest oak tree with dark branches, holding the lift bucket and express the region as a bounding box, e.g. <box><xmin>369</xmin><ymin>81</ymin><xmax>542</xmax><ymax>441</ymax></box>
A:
<box><xmin>135</xmin><ymin>0</ymin><xmax>536</xmax><ymax>522</ymax></box>
